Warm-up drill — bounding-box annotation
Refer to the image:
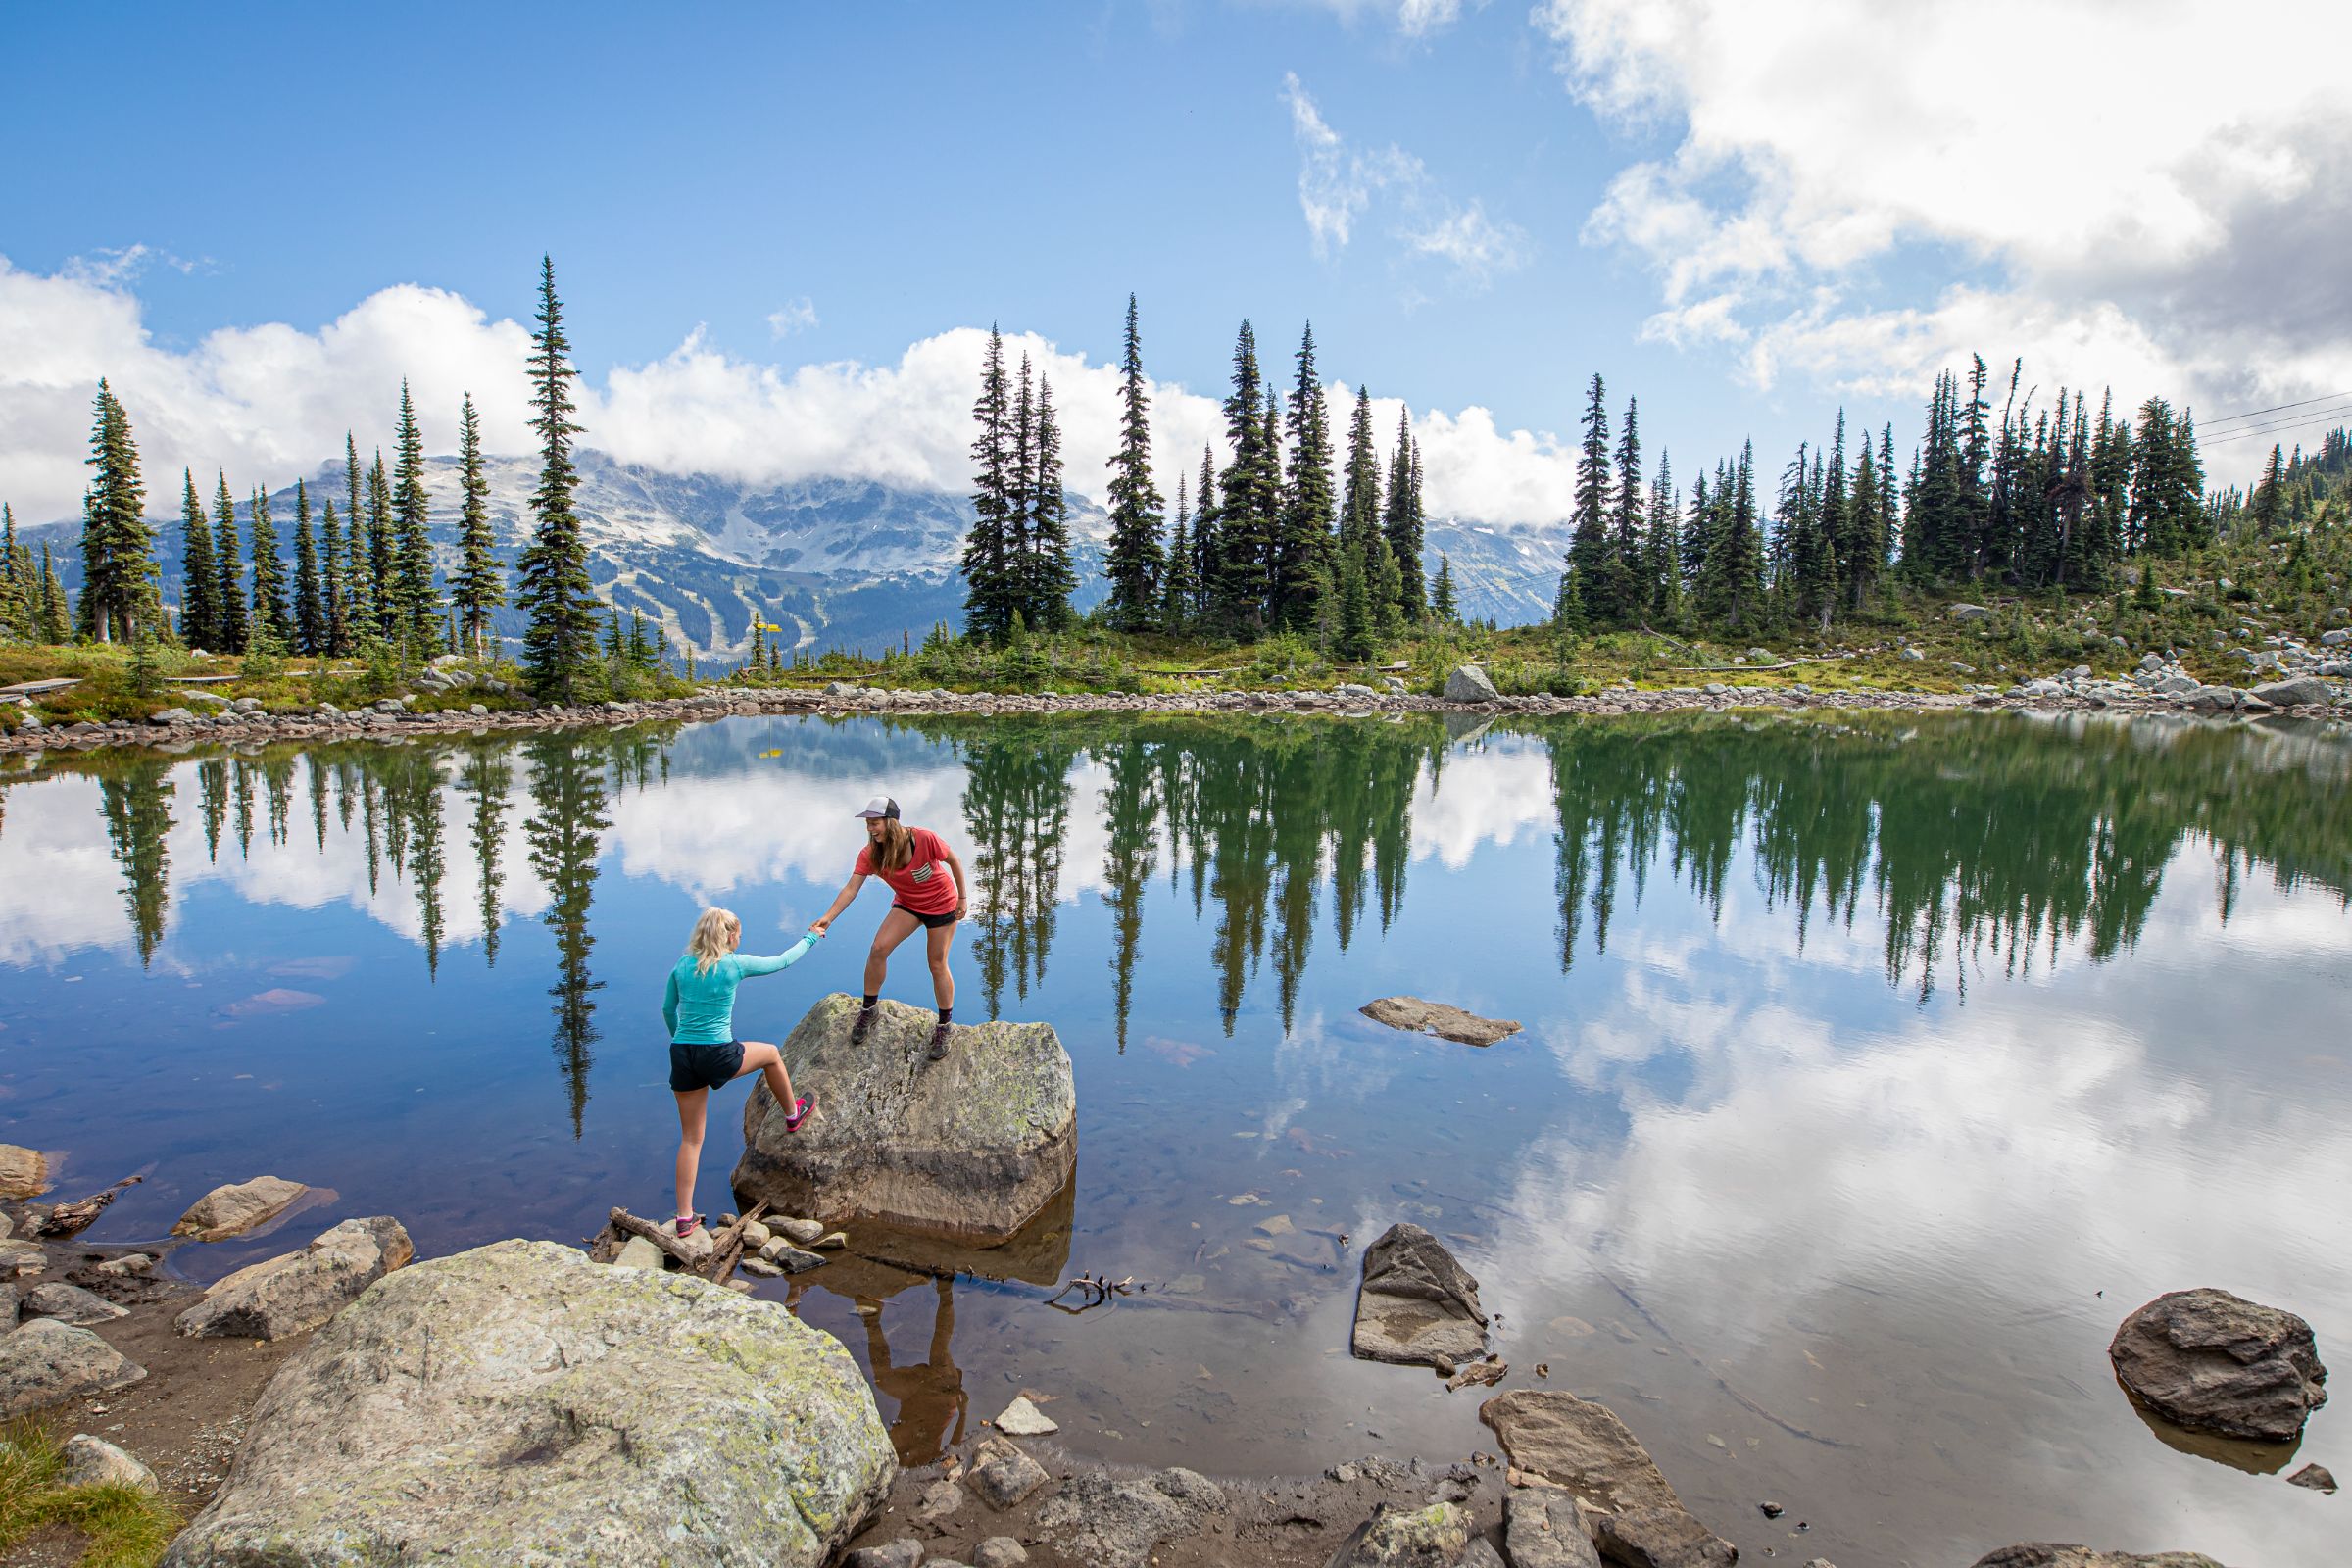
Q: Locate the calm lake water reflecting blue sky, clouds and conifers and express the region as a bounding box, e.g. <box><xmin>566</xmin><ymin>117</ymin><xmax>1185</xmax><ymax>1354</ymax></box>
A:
<box><xmin>0</xmin><ymin>714</ymin><xmax>2352</xmax><ymax>1568</ymax></box>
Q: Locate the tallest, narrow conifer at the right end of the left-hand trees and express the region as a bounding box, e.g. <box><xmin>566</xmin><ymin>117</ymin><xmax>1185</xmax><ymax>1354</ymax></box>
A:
<box><xmin>515</xmin><ymin>256</ymin><xmax>595</xmax><ymax>703</ymax></box>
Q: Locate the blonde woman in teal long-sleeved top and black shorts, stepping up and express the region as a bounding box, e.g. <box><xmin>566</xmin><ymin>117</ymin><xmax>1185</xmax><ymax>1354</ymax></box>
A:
<box><xmin>661</xmin><ymin>909</ymin><xmax>823</xmax><ymax>1237</ymax></box>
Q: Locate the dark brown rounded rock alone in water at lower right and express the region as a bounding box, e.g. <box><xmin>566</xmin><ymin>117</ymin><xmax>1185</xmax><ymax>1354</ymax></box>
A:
<box><xmin>2107</xmin><ymin>1289</ymin><xmax>2328</xmax><ymax>1444</ymax></box>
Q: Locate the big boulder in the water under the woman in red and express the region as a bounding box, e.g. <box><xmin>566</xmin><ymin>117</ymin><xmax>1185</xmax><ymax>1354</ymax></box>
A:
<box><xmin>734</xmin><ymin>995</ymin><xmax>1077</xmax><ymax>1242</ymax></box>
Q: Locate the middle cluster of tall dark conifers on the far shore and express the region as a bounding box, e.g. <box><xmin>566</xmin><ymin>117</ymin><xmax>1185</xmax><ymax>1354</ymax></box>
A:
<box><xmin>964</xmin><ymin>296</ymin><xmax>1451</xmax><ymax>659</ymax></box>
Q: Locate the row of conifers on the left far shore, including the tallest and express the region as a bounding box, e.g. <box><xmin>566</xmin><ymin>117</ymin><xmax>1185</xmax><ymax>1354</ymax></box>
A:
<box><xmin>14</xmin><ymin>259</ymin><xmax>597</xmax><ymax>701</ymax></box>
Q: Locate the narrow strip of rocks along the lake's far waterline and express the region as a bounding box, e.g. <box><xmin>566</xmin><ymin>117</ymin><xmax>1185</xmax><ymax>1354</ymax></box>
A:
<box><xmin>0</xmin><ymin>672</ymin><xmax>2352</xmax><ymax>755</ymax></box>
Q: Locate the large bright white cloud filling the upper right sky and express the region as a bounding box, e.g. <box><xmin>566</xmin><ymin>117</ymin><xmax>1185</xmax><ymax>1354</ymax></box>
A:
<box><xmin>1534</xmin><ymin>0</ymin><xmax>2352</xmax><ymax>429</ymax></box>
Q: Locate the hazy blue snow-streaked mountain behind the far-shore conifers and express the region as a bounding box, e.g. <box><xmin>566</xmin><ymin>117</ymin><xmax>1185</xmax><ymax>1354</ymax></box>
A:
<box><xmin>22</xmin><ymin>452</ymin><xmax>1559</xmax><ymax>661</ymax></box>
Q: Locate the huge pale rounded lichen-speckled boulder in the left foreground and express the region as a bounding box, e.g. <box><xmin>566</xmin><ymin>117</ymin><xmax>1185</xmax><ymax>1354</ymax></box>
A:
<box><xmin>165</xmin><ymin>1242</ymin><xmax>899</xmax><ymax>1568</ymax></box>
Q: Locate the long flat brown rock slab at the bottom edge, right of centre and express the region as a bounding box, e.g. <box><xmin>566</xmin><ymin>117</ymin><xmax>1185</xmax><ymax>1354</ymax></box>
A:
<box><xmin>1477</xmin><ymin>1390</ymin><xmax>1740</xmax><ymax>1568</ymax></box>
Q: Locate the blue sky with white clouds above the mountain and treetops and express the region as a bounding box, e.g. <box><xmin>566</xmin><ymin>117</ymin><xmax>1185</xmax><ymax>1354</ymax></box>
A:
<box><xmin>0</xmin><ymin>0</ymin><xmax>2352</xmax><ymax>522</ymax></box>
